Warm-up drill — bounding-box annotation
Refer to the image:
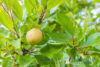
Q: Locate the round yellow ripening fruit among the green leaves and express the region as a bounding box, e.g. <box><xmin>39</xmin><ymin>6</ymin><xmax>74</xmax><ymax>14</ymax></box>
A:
<box><xmin>26</xmin><ymin>28</ymin><xmax>42</xmax><ymax>45</ymax></box>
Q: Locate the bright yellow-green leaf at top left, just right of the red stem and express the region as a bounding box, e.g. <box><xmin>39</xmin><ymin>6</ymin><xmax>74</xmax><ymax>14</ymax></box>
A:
<box><xmin>4</xmin><ymin>0</ymin><xmax>23</xmax><ymax>21</ymax></box>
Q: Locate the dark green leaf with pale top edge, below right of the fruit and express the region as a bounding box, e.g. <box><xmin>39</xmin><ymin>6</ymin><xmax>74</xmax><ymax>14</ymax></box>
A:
<box><xmin>40</xmin><ymin>43</ymin><xmax>65</xmax><ymax>58</ymax></box>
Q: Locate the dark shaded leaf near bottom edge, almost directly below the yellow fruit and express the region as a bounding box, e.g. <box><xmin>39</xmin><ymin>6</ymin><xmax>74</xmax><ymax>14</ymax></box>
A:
<box><xmin>35</xmin><ymin>55</ymin><xmax>54</xmax><ymax>65</ymax></box>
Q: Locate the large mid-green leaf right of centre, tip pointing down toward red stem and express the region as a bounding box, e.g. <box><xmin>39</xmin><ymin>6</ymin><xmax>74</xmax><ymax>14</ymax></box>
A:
<box><xmin>56</xmin><ymin>13</ymin><xmax>73</xmax><ymax>35</ymax></box>
